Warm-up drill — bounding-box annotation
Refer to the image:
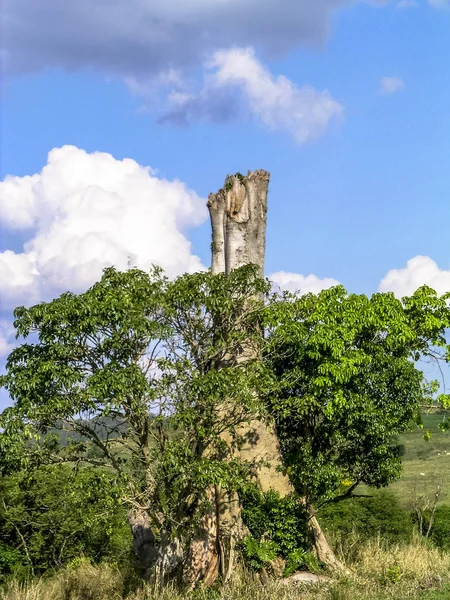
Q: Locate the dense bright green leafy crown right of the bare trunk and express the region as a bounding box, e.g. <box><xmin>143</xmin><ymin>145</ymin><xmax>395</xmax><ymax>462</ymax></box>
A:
<box><xmin>266</xmin><ymin>286</ymin><xmax>449</xmax><ymax>504</ymax></box>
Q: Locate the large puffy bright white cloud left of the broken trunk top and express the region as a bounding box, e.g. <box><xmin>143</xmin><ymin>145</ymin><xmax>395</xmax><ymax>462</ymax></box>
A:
<box><xmin>0</xmin><ymin>146</ymin><xmax>207</xmax><ymax>308</ymax></box>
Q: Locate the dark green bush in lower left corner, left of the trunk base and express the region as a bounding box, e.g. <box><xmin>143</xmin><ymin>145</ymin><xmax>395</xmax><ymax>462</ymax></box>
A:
<box><xmin>0</xmin><ymin>466</ymin><xmax>132</xmax><ymax>576</ymax></box>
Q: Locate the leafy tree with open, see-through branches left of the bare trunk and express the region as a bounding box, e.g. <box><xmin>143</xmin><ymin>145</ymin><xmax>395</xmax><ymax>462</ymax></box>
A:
<box><xmin>0</xmin><ymin>267</ymin><xmax>276</xmax><ymax>583</ymax></box>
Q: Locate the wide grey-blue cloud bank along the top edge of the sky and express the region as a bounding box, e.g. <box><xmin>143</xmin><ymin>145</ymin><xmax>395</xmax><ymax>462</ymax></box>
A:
<box><xmin>2</xmin><ymin>0</ymin><xmax>388</xmax><ymax>77</ymax></box>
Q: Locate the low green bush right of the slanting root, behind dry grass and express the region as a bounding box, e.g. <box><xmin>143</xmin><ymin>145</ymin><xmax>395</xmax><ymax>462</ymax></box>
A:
<box><xmin>317</xmin><ymin>490</ymin><xmax>414</xmax><ymax>543</ymax></box>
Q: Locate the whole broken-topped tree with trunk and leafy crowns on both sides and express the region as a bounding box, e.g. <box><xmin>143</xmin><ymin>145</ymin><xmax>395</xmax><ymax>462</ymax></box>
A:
<box><xmin>0</xmin><ymin>166</ymin><xmax>449</xmax><ymax>587</ymax></box>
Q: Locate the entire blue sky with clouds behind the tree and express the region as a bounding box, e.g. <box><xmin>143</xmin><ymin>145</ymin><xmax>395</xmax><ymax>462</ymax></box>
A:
<box><xmin>0</xmin><ymin>0</ymin><xmax>450</xmax><ymax>406</ymax></box>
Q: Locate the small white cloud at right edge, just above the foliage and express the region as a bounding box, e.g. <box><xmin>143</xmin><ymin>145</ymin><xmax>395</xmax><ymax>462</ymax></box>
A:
<box><xmin>378</xmin><ymin>256</ymin><xmax>450</xmax><ymax>298</ymax></box>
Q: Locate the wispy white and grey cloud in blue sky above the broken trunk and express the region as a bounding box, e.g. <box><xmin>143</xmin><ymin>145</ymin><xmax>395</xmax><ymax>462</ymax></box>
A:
<box><xmin>161</xmin><ymin>48</ymin><xmax>343</xmax><ymax>143</ymax></box>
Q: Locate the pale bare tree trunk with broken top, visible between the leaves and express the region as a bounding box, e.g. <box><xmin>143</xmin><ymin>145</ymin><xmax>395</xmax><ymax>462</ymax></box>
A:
<box><xmin>185</xmin><ymin>171</ymin><xmax>291</xmax><ymax>583</ymax></box>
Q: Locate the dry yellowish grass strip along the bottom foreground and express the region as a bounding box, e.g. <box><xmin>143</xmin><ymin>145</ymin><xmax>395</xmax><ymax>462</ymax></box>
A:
<box><xmin>0</xmin><ymin>538</ymin><xmax>450</xmax><ymax>600</ymax></box>
